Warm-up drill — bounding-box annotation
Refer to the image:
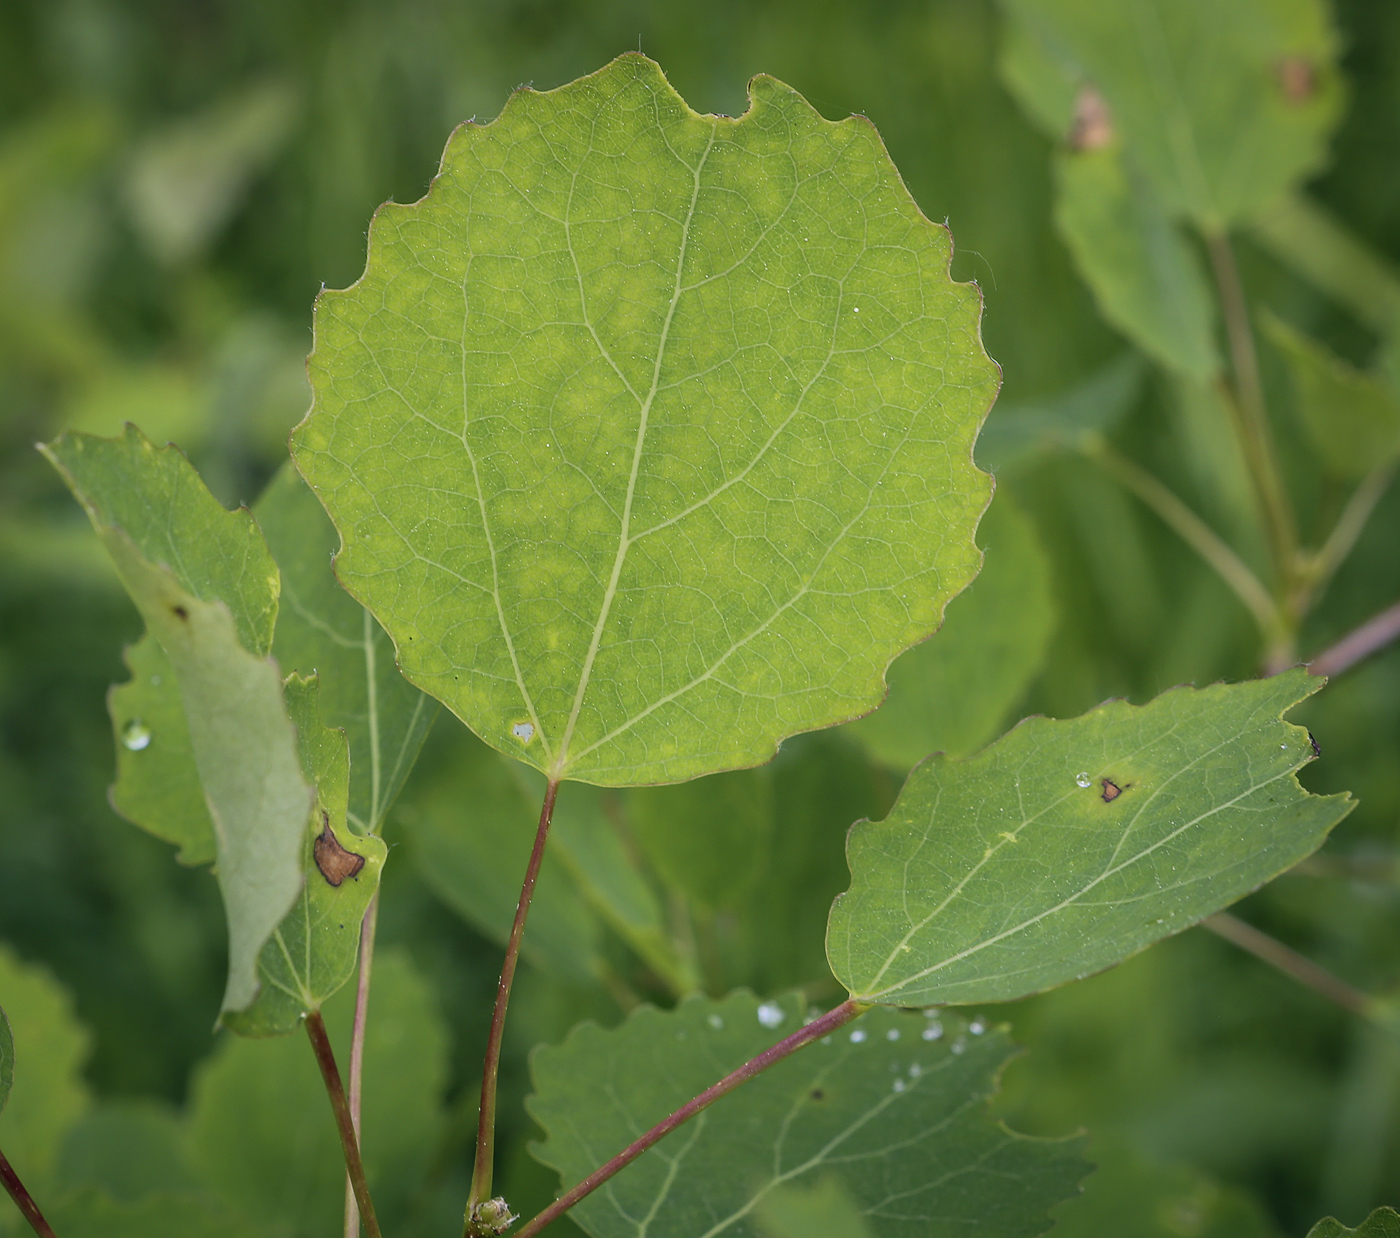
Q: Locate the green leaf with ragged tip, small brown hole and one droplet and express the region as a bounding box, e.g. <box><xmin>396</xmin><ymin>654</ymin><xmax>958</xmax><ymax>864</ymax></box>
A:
<box><xmin>826</xmin><ymin>669</ymin><xmax>1352</xmax><ymax>1006</ymax></box>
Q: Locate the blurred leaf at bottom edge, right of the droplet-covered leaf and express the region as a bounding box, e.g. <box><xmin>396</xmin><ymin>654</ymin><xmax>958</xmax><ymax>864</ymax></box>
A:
<box><xmin>1054</xmin><ymin>1144</ymin><xmax>1281</xmax><ymax>1238</ymax></box>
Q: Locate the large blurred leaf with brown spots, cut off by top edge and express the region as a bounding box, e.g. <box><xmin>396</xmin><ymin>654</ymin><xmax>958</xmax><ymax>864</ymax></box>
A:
<box><xmin>1005</xmin><ymin>0</ymin><xmax>1341</xmax><ymax>232</ymax></box>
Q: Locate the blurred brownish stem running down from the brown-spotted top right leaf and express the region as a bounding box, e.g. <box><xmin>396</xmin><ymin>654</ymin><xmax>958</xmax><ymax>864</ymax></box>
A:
<box><xmin>1205</xmin><ymin>232</ymin><xmax>1298</xmax><ymax>574</ymax></box>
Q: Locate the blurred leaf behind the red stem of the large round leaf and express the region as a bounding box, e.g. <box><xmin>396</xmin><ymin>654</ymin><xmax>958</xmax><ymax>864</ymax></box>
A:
<box><xmin>406</xmin><ymin>737</ymin><xmax>599</xmax><ymax>982</ymax></box>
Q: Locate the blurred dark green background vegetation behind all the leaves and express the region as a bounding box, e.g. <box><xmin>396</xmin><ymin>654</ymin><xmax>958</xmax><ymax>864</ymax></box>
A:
<box><xmin>0</xmin><ymin>0</ymin><xmax>1400</xmax><ymax>1238</ymax></box>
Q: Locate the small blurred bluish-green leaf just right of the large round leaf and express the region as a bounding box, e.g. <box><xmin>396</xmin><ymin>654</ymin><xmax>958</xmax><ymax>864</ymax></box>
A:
<box><xmin>977</xmin><ymin>352</ymin><xmax>1147</xmax><ymax>473</ymax></box>
